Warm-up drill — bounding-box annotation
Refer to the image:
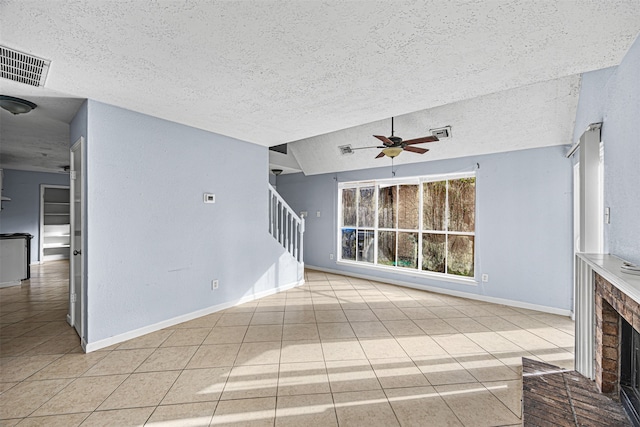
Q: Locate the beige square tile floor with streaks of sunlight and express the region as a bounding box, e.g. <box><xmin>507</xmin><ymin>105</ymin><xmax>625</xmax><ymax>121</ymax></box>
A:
<box><xmin>0</xmin><ymin>262</ymin><xmax>574</xmax><ymax>427</ymax></box>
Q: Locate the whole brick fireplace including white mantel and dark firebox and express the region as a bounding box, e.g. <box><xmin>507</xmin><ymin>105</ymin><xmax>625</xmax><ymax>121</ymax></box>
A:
<box><xmin>574</xmin><ymin>254</ymin><xmax>640</xmax><ymax>427</ymax></box>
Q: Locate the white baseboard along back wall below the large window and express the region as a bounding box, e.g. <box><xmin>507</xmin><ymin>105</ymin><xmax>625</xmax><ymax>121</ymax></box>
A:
<box><xmin>306</xmin><ymin>265</ymin><xmax>572</xmax><ymax>316</ymax></box>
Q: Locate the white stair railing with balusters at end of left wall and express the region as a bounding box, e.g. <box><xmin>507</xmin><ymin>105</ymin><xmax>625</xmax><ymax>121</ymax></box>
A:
<box><xmin>268</xmin><ymin>184</ymin><xmax>304</xmax><ymax>264</ymax></box>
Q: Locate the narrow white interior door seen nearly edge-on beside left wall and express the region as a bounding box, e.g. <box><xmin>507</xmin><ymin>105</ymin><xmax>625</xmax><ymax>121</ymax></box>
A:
<box><xmin>69</xmin><ymin>137</ymin><xmax>85</xmax><ymax>339</ymax></box>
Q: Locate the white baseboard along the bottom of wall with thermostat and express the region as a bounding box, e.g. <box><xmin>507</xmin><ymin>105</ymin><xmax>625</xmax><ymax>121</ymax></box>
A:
<box><xmin>82</xmin><ymin>279</ymin><xmax>304</xmax><ymax>353</ymax></box>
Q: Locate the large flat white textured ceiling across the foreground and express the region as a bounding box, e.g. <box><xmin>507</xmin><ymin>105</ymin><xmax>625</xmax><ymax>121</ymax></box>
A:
<box><xmin>0</xmin><ymin>0</ymin><xmax>640</xmax><ymax>172</ymax></box>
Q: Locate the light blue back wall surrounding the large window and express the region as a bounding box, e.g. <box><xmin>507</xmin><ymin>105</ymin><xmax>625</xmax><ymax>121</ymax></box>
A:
<box><xmin>278</xmin><ymin>146</ymin><xmax>573</xmax><ymax>310</ymax></box>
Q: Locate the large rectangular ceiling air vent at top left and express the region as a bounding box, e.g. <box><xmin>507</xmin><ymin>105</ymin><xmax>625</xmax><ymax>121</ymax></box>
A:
<box><xmin>0</xmin><ymin>46</ymin><xmax>51</xmax><ymax>86</ymax></box>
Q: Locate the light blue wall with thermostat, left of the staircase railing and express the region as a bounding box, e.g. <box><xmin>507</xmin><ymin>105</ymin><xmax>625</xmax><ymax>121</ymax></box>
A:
<box><xmin>79</xmin><ymin>100</ymin><xmax>298</xmax><ymax>343</ymax></box>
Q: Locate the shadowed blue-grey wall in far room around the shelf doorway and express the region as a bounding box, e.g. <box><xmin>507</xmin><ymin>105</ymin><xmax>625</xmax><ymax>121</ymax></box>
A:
<box><xmin>0</xmin><ymin>169</ymin><xmax>69</xmax><ymax>263</ymax></box>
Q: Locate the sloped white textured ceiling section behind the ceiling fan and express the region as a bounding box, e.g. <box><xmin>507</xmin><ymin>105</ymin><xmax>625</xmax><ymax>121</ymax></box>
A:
<box><xmin>289</xmin><ymin>75</ymin><xmax>580</xmax><ymax>175</ymax></box>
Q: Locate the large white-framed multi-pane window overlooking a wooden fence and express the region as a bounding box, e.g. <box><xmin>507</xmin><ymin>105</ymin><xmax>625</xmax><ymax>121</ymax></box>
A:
<box><xmin>338</xmin><ymin>174</ymin><xmax>476</xmax><ymax>278</ymax></box>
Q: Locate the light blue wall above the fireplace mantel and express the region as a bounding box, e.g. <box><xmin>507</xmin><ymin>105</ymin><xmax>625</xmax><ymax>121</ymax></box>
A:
<box><xmin>574</xmin><ymin>33</ymin><xmax>640</xmax><ymax>264</ymax></box>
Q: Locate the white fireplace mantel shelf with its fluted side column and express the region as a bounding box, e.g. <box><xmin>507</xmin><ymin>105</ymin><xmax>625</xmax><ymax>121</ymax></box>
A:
<box><xmin>574</xmin><ymin>254</ymin><xmax>640</xmax><ymax>379</ymax></box>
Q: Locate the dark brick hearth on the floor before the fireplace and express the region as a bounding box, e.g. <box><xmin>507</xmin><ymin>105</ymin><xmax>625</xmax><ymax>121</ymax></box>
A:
<box><xmin>522</xmin><ymin>357</ymin><xmax>632</xmax><ymax>427</ymax></box>
